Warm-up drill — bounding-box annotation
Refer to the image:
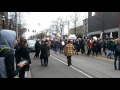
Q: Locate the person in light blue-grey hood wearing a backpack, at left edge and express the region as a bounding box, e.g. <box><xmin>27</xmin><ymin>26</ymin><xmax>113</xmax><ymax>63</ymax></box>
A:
<box><xmin>0</xmin><ymin>30</ymin><xmax>25</xmax><ymax>78</ymax></box>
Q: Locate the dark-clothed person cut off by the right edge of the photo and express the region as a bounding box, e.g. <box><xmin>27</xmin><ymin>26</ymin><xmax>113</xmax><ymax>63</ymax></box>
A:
<box><xmin>114</xmin><ymin>39</ymin><xmax>120</xmax><ymax>70</ymax></box>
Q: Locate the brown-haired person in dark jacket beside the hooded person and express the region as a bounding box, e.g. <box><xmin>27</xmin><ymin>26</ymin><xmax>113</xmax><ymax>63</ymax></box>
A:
<box><xmin>19</xmin><ymin>37</ymin><xmax>31</xmax><ymax>78</ymax></box>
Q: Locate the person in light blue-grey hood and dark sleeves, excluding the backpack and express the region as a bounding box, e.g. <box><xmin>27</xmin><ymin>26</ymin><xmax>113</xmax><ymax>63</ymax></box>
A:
<box><xmin>0</xmin><ymin>30</ymin><xmax>25</xmax><ymax>78</ymax></box>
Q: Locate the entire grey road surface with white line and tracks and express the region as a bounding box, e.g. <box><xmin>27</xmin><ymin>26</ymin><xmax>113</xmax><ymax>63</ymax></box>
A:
<box><xmin>30</xmin><ymin>51</ymin><xmax>120</xmax><ymax>78</ymax></box>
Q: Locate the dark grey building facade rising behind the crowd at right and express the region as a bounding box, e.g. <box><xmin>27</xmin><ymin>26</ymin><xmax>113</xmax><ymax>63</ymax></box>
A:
<box><xmin>88</xmin><ymin>12</ymin><xmax>120</xmax><ymax>38</ymax></box>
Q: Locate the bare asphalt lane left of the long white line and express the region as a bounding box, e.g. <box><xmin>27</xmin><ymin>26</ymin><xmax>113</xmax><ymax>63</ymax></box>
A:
<box><xmin>30</xmin><ymin>53</ymin><xmax>89</xmax><ymax>78</ymax></box>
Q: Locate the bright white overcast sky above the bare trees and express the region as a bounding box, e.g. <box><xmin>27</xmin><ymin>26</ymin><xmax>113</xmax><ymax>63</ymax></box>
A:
<box><xmin>24</xmin><ymin>12</ymin><xmax>87</xmax><ymax>38</ymax></box>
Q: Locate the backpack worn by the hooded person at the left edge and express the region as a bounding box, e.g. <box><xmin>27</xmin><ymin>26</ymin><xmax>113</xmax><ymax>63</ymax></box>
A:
<box><xmin>0</xmin><ymin>45</ymin><xmax>11</xmax><ymax>78</ymax></box>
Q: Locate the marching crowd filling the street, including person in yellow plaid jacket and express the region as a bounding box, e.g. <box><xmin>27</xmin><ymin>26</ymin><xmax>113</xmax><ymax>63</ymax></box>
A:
<box><xmin>47</xmin><ymin>38</ymin><xmax>120</xmax><ymax>70</ymax></box>
